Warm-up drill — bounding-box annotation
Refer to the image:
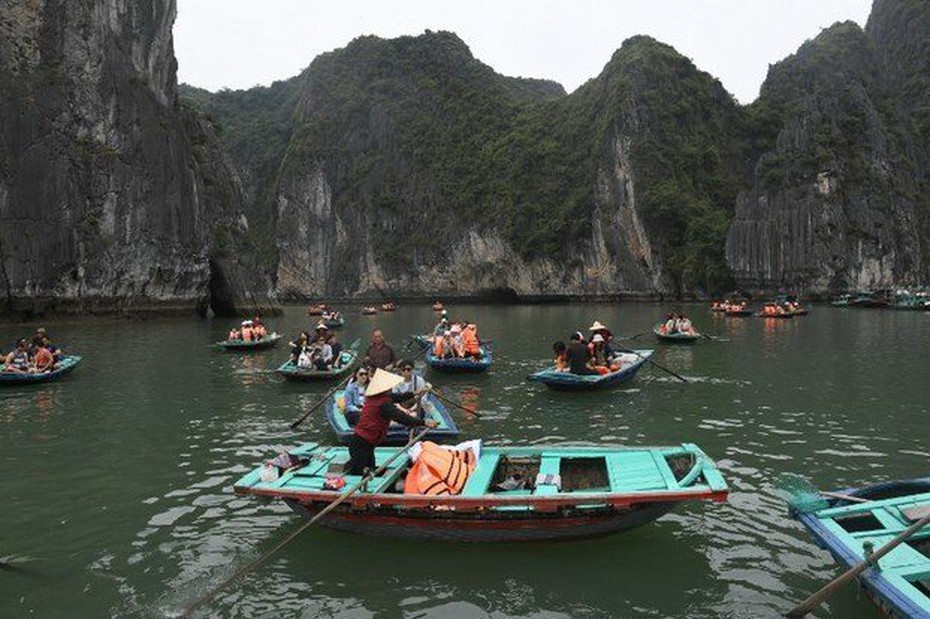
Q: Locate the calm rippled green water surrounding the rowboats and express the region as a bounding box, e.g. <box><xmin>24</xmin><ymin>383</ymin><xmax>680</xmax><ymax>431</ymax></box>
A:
<box><xmin>0</xmin><ymin>304</ymin><xmax>930</xmax><ymax>618</ymax></box>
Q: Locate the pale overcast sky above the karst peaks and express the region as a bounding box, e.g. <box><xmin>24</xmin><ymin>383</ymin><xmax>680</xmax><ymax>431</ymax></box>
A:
<box><xmin>174</xmin><ymin>0</ymin><xmax>872</xmax><ymax>103</ymax></box>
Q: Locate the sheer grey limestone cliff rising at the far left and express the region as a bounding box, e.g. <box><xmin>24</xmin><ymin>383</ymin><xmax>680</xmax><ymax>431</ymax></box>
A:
<box><xmin>0</xmin><ymin>0</ymin><xmax>271</xmax><ymax>313</ymax></box>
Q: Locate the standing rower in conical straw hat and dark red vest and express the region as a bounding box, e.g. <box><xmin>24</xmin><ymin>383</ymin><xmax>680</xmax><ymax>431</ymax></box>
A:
<box><xmin>346</xmin><ymin>368</ymin><xmax>439</xmax><ymax>475</ymax></box>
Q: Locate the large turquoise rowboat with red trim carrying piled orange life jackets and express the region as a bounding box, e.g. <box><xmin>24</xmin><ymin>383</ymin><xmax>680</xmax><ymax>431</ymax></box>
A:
<box><xmin>234</xmin><ymin>443</ymin><xmax>728</xmax><ymax>542</ymax></box>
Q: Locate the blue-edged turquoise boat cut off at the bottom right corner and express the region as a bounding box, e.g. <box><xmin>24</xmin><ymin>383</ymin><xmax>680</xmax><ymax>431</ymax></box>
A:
<box><xmin>791</xmin><ymin>477</ymin><xmax>930</xmax><ymax>619</ymax></box>
